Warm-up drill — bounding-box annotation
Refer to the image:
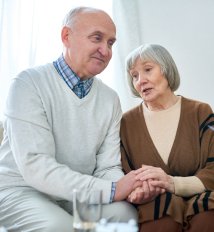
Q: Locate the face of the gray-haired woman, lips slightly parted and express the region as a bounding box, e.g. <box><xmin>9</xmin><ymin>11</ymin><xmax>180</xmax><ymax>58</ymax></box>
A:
<box><xmin>130</xmin><ymin>59</ymin><xmax>171</xmax><ymax>103</ymax></box>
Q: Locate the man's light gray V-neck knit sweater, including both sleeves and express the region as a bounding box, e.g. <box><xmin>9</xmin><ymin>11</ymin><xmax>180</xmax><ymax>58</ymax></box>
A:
<box><xmin>0</xmin><ymin>64</ymin><xmax>123</xmax><ymax>203</ymax></box>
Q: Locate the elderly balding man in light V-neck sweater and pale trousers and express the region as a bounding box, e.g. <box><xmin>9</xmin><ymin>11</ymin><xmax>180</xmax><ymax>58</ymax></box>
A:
<box><xmin>0</xmin><ymin>7</ymin><xmax>138</xmax><ymax>232</ymax></box>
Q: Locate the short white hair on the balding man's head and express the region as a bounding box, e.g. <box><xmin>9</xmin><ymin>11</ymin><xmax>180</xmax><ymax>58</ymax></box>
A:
<box><xmin>62</xmin><ymin>6</ymin><xmax>104</xmax><ymax>27</ymax></box>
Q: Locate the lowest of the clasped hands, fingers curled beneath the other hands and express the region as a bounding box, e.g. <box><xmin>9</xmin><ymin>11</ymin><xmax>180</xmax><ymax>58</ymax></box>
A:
<box><xmin>127</xmin><ymin>180</ymin><xmax>165</xmax><ymax>204</ymax></box>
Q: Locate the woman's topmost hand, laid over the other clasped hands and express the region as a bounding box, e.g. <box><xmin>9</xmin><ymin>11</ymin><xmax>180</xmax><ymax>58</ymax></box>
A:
<box><xmin>135</xmin><ymin>165</ymin><xmax>175</xmax><ymax>193</ymax></box>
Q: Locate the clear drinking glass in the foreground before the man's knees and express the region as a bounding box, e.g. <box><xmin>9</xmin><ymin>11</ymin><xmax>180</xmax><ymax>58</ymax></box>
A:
<box><xmin>73</xmin><ymin>189</ymin><xmax>102</xmax><ymax>232</ymax></box>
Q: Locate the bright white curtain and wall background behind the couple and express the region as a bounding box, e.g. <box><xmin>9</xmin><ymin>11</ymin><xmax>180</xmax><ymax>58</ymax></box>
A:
<box><xmin>0</xmin><ymin>0</ymin><xmax>214</xmax><ymax>119</ymax></box>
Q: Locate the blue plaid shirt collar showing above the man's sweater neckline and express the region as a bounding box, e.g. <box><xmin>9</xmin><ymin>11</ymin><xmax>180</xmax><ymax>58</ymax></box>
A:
<box><xmin>53</xmin><ymin>55</ymin><xmax>93</xmax><ymax>98</ymax></box>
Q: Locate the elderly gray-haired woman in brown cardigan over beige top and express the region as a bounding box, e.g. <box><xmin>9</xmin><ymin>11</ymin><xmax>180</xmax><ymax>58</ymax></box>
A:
<box><xmin>121</xmin><ymin>44</ymin><xmax>214</xmax><ymax>232</ymax></box>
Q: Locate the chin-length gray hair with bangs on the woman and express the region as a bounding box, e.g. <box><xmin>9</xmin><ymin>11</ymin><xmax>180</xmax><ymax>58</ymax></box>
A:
<box><xmin>125</xmin><ymin>44</ymin><xmax>180</xmax><ymax>97</ymax></box>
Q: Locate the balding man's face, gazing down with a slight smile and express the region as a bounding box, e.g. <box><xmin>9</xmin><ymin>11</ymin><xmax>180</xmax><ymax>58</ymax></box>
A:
<box><xmin>64</xmin><ymin>12</ymin><xmax>116</xmax><ymax>79</ymax></box>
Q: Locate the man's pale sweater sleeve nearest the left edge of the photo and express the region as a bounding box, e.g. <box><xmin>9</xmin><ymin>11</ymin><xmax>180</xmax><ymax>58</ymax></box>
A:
<box><xmin>5</xmin><ymin>74</ymin><xmax>112</xmax><ymax>203</ymax></box>
